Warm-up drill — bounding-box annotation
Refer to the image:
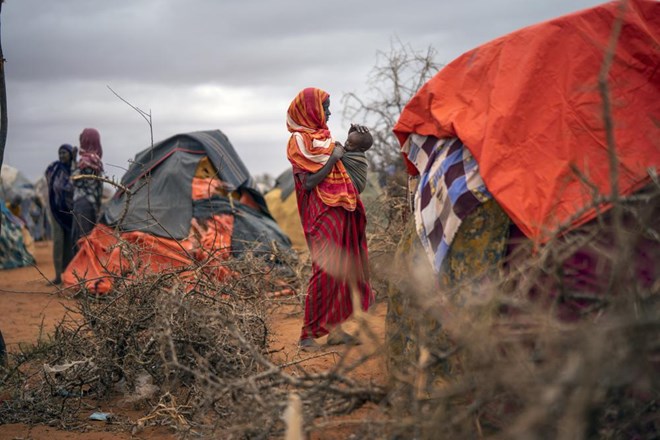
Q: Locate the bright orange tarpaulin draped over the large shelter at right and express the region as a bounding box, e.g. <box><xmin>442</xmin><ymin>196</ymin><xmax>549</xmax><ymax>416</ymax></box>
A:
<box><xmin>394</xmin><ymin>0</ymin><xmax>660</xmax><ymax>241</ymax></box>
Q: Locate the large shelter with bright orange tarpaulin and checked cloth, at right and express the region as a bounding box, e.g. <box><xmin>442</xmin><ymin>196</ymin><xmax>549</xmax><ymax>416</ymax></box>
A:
<box><xmin>387</xmin><ymin>0</ymin><xmax>660</xmax><ymax>382</ymax></box>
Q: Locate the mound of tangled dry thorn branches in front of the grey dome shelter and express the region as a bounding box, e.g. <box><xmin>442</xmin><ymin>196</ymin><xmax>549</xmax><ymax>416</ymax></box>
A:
<box><xmin>2</xmin><ymin>248</ymin><xmax>268</xmax><ymax>430</ymax></box>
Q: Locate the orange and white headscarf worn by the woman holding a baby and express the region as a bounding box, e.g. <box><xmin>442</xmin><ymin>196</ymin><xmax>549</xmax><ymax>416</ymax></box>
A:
<box><xmin>286</xmin><ymin>87</ymin><xmax>357</xmax><ymax>211</ymax></box>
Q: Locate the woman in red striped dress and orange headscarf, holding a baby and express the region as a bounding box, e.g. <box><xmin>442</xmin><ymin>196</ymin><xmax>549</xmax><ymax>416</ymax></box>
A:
<box><xmin>287</xmin><ymin>88</ymin><xmax>374</xmax><ymax>350</ymax></box>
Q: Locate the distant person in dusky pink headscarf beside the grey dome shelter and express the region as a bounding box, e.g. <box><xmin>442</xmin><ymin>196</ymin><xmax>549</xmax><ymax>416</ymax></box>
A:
<box><xmin>71</xmin><ymin>128</ymin><xmax>103</xmax><ymax>252</ymax></box>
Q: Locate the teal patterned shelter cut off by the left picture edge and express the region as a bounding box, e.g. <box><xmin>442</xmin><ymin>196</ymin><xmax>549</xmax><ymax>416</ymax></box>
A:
<box><xmin>0</xmin><ymin>199</ymin><xmax>35</xmax><ymax>269</ymax></box>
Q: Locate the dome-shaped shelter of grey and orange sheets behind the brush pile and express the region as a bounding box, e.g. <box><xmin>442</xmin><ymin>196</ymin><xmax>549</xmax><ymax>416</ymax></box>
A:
<box><xmin>62</xmin><ymin>130</ymin><xmax>291</xmax><ymax>294</ymax></box>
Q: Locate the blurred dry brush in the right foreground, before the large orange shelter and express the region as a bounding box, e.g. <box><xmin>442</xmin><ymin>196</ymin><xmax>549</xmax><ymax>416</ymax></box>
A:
<box><xmin>373</xmin><ymin>182</ymin><xmax>660</xmax><ymax>439</ymax></box>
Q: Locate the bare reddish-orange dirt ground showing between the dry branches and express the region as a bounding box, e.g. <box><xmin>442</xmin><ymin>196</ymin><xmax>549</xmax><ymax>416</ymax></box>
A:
<box><xmin>0</xmin><ymin>242</ymin><xmax>386</xmax><ymax>440</ymax></box>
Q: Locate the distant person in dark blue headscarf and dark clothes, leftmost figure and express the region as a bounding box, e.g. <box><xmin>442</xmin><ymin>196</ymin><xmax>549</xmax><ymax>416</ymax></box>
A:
<box><xmin>46</xmin><ymin>144</ymin><xmax>75</xmax><ymax>284</ymax></box>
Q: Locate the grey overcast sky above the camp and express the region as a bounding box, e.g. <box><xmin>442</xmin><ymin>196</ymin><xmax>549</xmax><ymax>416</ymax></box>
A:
<box><xmin>1</xmin><ymin>0</ymin><xmax>603</xmax><ymax>180</ymax></box>
